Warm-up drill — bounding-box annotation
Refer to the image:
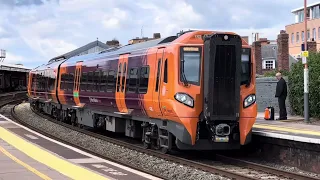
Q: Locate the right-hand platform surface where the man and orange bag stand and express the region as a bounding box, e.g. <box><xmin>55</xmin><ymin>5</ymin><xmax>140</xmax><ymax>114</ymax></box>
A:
<box><xmin>253</xmin><ymin>113</ymin><xmax>320</xmax><ymax>144</ymax></box>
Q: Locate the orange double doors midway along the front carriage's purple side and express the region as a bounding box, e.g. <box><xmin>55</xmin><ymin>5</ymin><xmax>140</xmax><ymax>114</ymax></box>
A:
<box><xmin>115</xmin><ymin>54</ymin><xmax>129</xmax><ymax>113</ymax></box>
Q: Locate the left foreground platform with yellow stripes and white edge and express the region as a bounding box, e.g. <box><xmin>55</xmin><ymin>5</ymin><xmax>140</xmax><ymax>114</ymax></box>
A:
<box><xmin>0</xmin><ymin>114</ymin><xmax>158</xmax><ymax>180</ymax></box>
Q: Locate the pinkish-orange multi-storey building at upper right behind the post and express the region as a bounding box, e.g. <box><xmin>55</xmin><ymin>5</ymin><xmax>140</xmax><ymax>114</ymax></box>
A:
<box><xmin>286</xmin><ymin>2</ymin><xmax>320</xmax><ymax>58</ymax></box>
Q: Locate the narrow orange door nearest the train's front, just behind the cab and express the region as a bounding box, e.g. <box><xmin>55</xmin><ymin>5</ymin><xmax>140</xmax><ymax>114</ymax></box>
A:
<box><xmin>152</xmin><ymin>48</ymin><xmax>165</xmax><ymax>116</ymax></box>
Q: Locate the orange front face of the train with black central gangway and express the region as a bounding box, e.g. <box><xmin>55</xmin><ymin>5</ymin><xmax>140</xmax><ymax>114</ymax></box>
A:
<box><xmin>171</xmin><ymin>32</ymin><xmax>257</xmax><ymax>150</ymax></box>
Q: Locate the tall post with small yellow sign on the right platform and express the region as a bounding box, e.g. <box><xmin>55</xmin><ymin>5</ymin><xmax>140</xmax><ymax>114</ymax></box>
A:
<box><xmin>302</xmin><ymin>0</ymin><xmax>310</xmax><ymax>123</ymax></box>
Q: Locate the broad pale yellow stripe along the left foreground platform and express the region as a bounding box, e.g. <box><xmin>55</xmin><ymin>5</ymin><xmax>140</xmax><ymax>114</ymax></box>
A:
<box><xmin>0</xmin><ymin>127</ymin><xmax>107</xmax><ymax>180</ymax></box>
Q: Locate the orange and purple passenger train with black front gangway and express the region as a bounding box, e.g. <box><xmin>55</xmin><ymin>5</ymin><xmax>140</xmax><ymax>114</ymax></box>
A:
<box><xmin>29</xmin><ymin>31</ymin><xmax>257</xmax><ymax>151</ymax></box>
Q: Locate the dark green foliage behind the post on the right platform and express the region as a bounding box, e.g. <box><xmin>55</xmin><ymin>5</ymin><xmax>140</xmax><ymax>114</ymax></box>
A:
<box><xmin>288</xmin><ymin>52</ymin><xmax>320</xmax><ymax>117</ymax></box>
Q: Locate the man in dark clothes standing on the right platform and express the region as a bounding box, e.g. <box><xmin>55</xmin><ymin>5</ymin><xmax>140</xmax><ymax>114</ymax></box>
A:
<box><xmin>275</xmin><ymin>72</ymin><xmax>287</xmax><ymax>120</ymax></box>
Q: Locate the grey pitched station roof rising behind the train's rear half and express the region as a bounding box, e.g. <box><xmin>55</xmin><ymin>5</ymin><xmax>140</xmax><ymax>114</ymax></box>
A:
<box><xmin>49</xmin><ymin>40</ymin><xmax>110</xmax><ymax>62</ymax></box>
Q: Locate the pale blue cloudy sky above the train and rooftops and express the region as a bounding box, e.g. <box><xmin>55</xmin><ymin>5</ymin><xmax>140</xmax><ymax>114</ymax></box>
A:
<box><xmin>0</xmin><ymin>0</ymin><xmax>316</xmax><ymax>68</ymax></box>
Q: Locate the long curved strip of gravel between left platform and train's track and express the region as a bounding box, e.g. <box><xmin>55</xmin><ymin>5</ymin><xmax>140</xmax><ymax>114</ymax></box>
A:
<box><xmin>15</xmin><ymin>103</ymin><xmax>229</xmax><ymax>180</ymax></box>
